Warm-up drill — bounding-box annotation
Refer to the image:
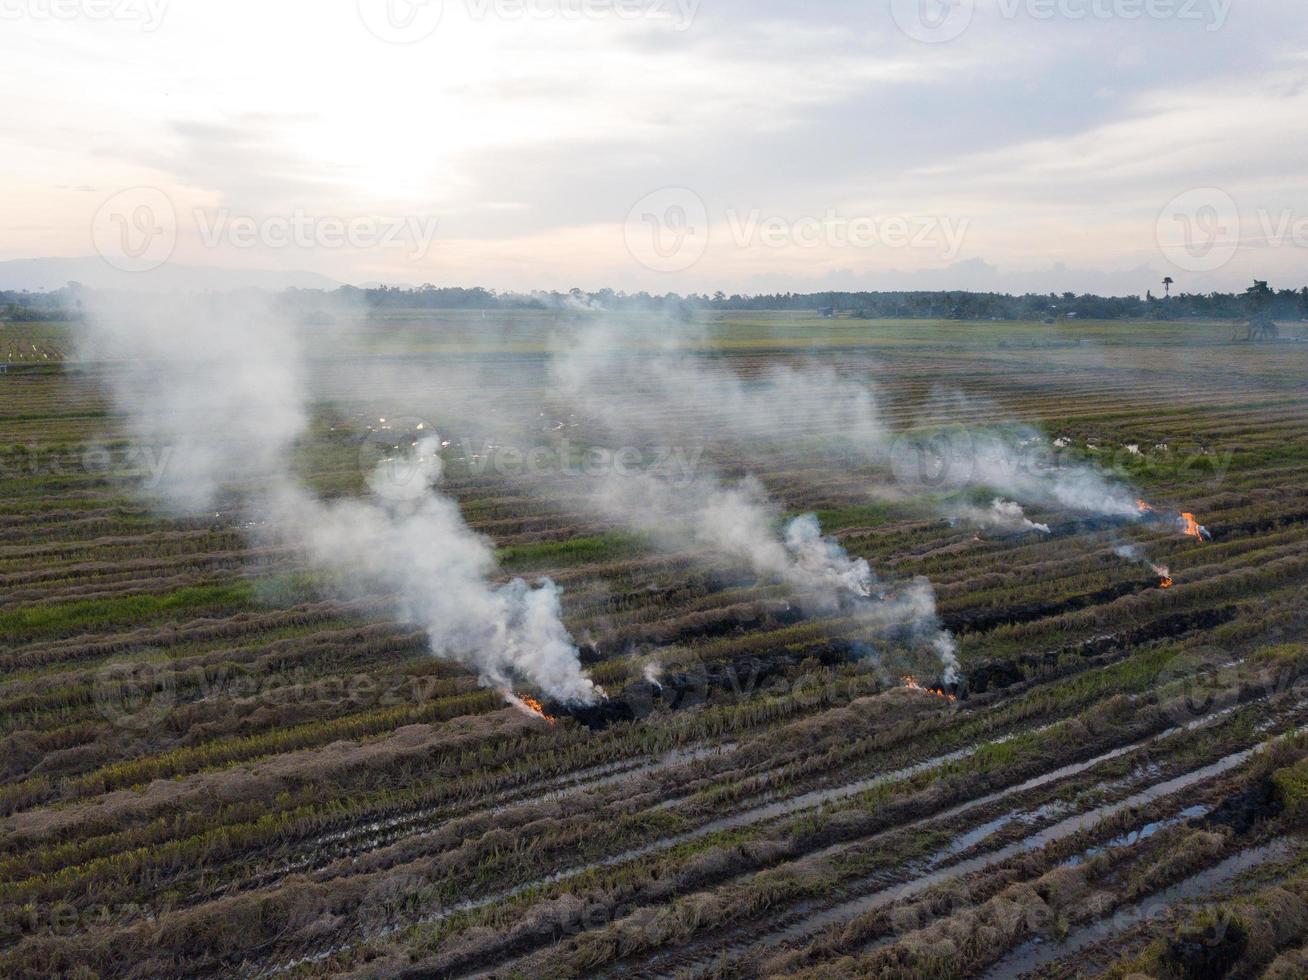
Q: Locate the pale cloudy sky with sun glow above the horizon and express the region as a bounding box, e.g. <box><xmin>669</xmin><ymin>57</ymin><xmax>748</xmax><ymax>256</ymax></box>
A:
<box><xmin>0</xmin><ymin>0</ymin><xmax>1308</xmax><ymax>294</ymax></box>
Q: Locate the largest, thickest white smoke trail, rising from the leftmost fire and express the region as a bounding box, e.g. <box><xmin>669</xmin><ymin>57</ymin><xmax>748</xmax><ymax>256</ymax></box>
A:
<box><xmin>84</xmin><ymin>290</ymin><xmax>603</xmax><ymax>704</ymax></box>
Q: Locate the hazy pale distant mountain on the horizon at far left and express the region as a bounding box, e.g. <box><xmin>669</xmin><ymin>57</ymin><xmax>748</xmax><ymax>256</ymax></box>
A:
<box><xmin>0</xmin><ymin>256</ymin><xmax>340</xmax><ymax>293</ymax></box>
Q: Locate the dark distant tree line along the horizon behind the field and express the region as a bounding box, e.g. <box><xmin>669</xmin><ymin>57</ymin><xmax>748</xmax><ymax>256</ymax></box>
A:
<box><xmin>10</xmin><ymin>280</ymin><xmax>1308</xmax><ymax>321</ymax></box>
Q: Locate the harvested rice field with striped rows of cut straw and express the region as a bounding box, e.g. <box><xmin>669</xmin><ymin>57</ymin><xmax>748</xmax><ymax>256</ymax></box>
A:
<box><xmin>0</xmin><ymin>313</ymin><xmax>1308</xmax><ymax>980</ymax></box>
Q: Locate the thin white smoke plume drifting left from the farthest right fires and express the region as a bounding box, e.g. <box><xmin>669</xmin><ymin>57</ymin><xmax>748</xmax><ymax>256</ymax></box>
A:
<box><xmin>555</xmin><ymin>326</ymin><xmax>1141</xmax><ymax>519</ymax></box>
